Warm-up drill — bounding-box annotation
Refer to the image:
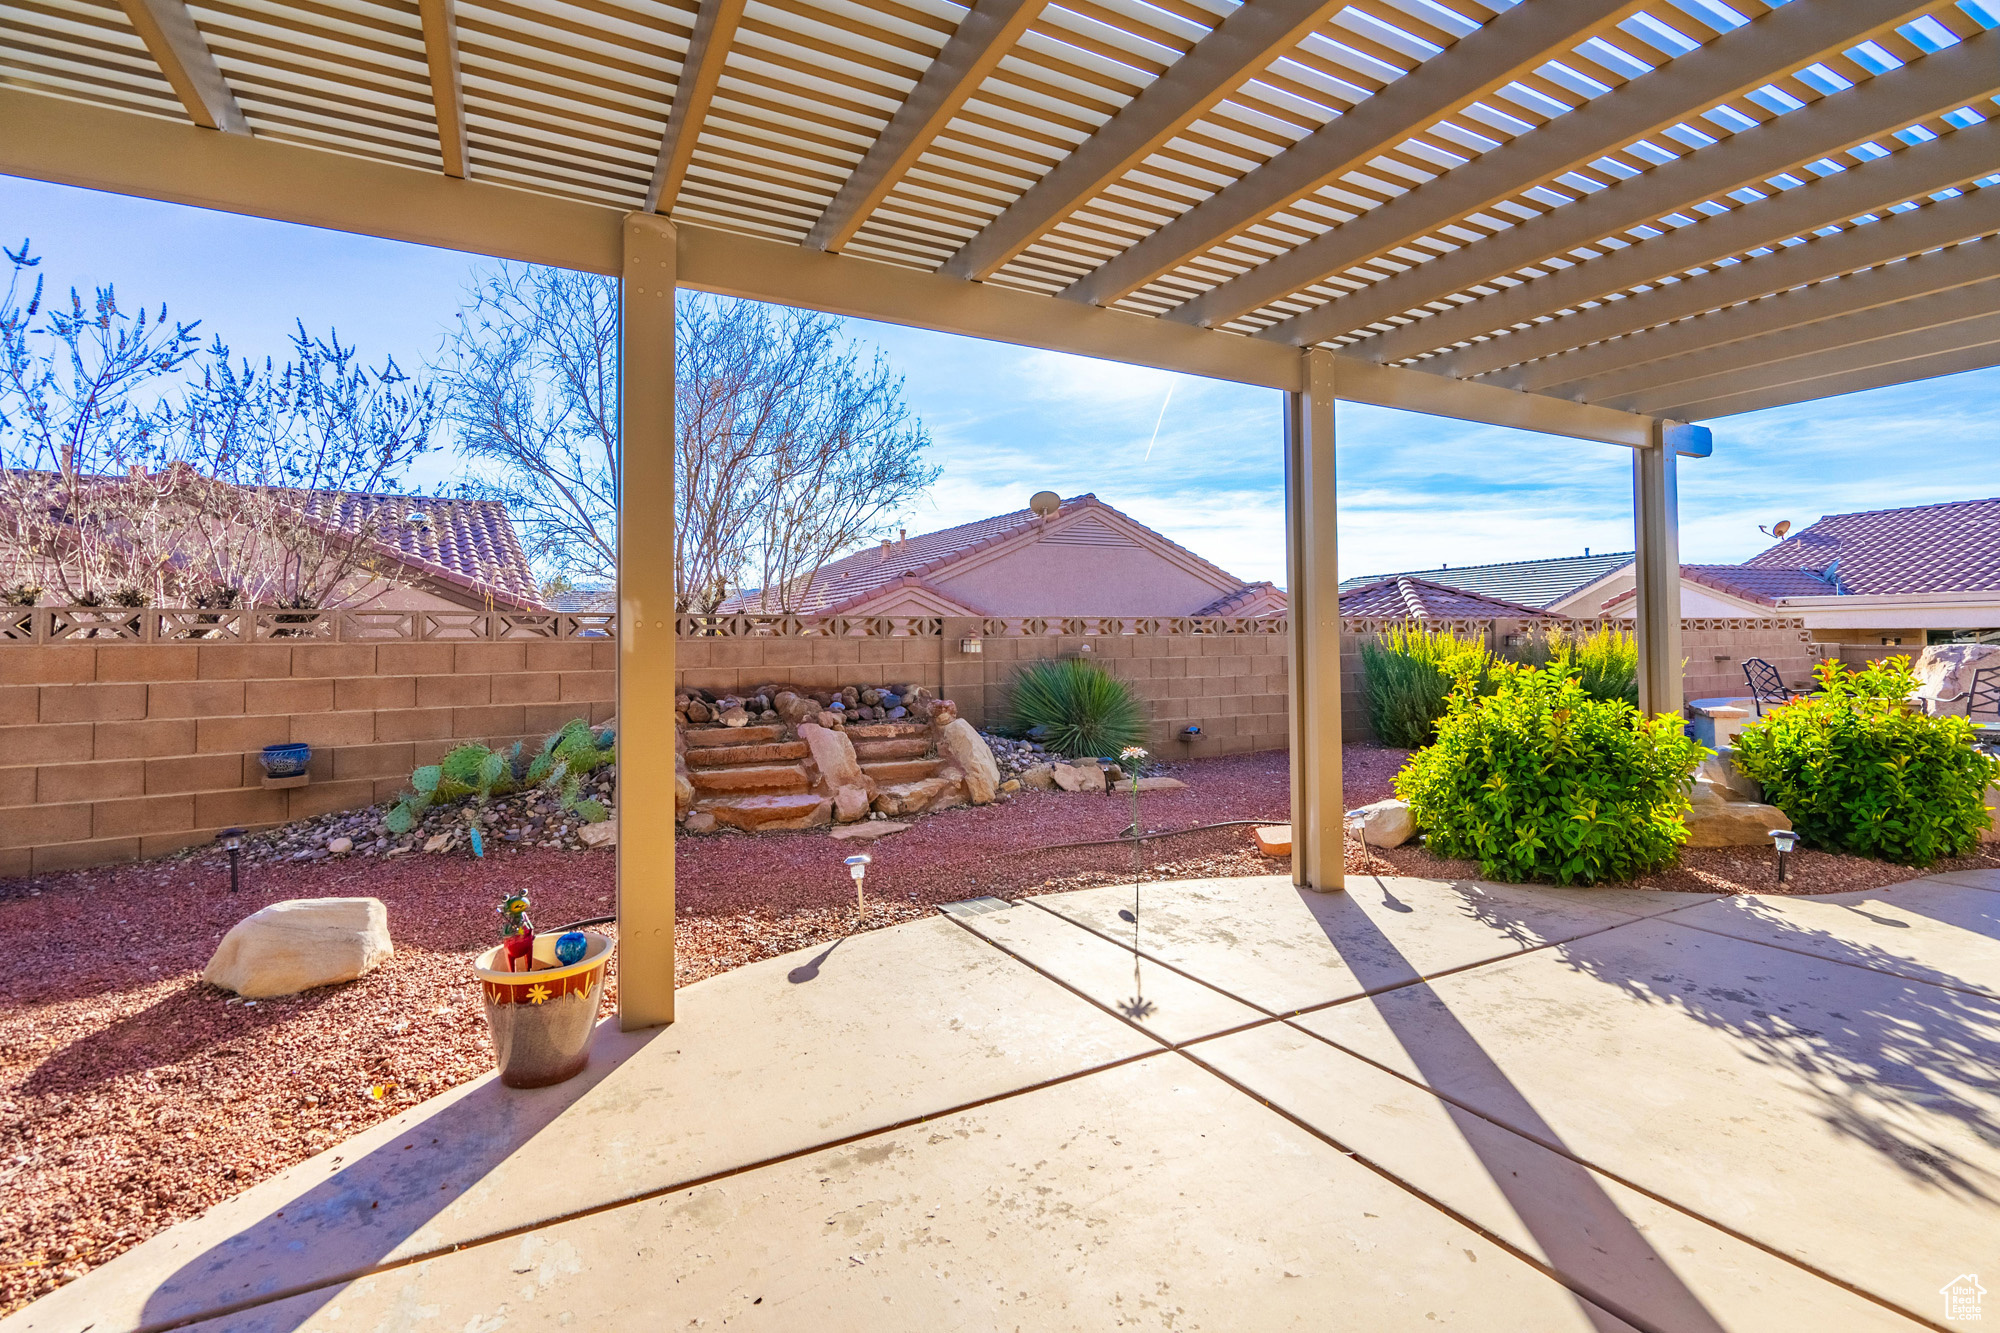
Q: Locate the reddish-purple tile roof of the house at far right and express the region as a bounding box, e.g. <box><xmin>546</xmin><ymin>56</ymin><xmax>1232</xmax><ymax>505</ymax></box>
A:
<box><xmin>1746</xmin><ymin>498</ymin><xmax>2000</xmax><ymax>596</ymax></box>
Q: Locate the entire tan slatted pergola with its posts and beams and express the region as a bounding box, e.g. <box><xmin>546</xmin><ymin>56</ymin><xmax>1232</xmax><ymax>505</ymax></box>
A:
<box><xmin>0</xmin><ymin>0</ymin><xmax>2000</xmax><ymax>1027</ymax></box>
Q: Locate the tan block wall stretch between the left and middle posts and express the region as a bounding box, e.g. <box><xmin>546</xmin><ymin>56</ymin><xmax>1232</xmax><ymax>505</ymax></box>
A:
<box><xmin>674</xmin><ymin>618</ymin><xmax>1288</xmax><ymax>759</ymax></box>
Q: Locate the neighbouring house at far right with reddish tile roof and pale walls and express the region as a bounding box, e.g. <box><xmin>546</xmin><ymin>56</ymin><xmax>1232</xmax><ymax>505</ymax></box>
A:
<box><xmin>1550</xmin><ymin>498</ymin><xmax>2000</xmax><ymax>648</ymax></box>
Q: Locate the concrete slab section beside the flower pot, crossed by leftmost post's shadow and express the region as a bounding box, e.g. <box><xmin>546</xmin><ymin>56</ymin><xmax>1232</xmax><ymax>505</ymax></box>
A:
<box><xmin>0</xmin><ymin>919</ymin><xmax>1160</xmax><ymax>1333</ymax></box>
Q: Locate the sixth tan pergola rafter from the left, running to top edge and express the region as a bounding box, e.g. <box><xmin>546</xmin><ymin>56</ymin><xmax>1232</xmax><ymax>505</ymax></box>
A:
<box><xmin>1062</xmin><ymin>0</ymin><xmax>1636</xmax><ymax>306</ymax></box>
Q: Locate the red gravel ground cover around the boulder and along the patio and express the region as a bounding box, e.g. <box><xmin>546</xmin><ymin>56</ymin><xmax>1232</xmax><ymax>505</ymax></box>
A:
<box><xmin>0</xmin><ymin>747</ymin><xmax>2000</xmax><ymax>1313</ymax></box>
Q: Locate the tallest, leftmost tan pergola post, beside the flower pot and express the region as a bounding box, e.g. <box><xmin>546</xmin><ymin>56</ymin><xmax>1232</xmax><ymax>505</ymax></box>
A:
<box><xmin>618</xmin><ymin>212</ymin><xmax>678</xmax><ymax>1031</ymax></box>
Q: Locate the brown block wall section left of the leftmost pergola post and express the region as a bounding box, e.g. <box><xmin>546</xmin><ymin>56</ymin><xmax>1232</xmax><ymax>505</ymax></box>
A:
<box><xmin>0</xmin><ymin>638</ymin><xmax>616</xmax><ymax>877</ymax></box>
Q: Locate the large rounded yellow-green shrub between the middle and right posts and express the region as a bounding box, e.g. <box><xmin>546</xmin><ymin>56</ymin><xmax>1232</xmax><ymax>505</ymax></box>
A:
<box><xmin>1396</xmin><ymin>662</ymin><xmax>1706</xmax><ymax>885</ymax></box>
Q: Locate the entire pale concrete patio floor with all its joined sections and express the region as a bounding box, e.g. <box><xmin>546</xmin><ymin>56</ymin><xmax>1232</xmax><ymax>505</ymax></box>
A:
<box><xmin>11</xmin><ymin>881</ymin><xmax>2000</xmax><ymax>1333</ymax></box>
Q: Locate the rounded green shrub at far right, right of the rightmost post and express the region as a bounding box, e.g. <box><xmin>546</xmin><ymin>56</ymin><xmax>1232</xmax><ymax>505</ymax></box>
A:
<box><xmin>1736</xmin><ymin>656</ymin><xmax>2000</xmax><ymax>865</ymax></box>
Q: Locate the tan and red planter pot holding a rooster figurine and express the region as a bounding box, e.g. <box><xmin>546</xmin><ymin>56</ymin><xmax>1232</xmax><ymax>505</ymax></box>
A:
<box><xmin>472</xmin><ymin>931</ymin><xmax>612</xmax><ymax>1087</ymax></box>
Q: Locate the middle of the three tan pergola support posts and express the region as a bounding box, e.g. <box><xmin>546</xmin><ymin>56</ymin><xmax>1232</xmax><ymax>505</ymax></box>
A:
<box><xmin>1284</xmin><ymin>348</ymin><xmax>1346</xmax><ymax>893</ymax></box>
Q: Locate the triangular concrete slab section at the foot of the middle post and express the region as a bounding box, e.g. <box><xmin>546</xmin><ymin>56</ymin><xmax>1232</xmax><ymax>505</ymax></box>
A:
<box><xmin>1032</xmin><ymin>875</ymin><xmax>1710</xmax><ymax>1015</ymax></box>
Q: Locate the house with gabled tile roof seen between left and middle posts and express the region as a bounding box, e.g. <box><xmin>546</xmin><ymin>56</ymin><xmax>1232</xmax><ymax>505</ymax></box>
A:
<box><xmin>720</xmin><ymin>494</ymin><xmax>1286</xmax><ymax>616</ymax></box>
